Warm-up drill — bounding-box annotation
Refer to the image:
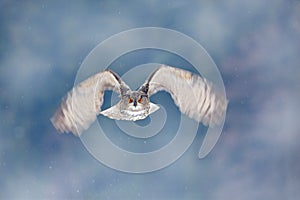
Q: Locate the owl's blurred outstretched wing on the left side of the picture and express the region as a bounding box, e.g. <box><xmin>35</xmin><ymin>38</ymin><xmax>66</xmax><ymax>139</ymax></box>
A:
<box><xmin>50</xmin><ymin>70</ymin><xmax>129</xmax><ymax>136</ymax></box>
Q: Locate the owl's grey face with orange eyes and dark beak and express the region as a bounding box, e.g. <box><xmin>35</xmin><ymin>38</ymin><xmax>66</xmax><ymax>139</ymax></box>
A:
<box><xmin>120</xmin><ymin>91</ymin><xmax>150</xmax><ymax>113</ymax></box>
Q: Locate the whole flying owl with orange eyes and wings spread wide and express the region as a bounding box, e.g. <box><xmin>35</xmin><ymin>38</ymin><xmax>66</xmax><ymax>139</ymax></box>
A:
<box><xmin>51</xmin><ymin>65</ymin><xmax>227</xmax><ymax>136</ymax></box>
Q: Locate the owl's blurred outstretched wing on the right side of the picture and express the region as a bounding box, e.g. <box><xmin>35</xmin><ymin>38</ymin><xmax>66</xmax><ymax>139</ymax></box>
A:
<box><xmin>140</xmin><ymin>65</ymin><xmax>227</xmax><ymax>126</ymax></box>
